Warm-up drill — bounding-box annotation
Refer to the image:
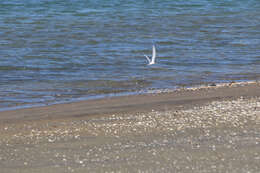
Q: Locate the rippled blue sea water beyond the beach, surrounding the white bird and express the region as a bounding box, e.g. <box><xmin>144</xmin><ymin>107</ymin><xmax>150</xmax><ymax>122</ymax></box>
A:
<box><xmin>0</xmin><ymin>0</ymin><xmax>260</xmax><ymax>110</ymax></box>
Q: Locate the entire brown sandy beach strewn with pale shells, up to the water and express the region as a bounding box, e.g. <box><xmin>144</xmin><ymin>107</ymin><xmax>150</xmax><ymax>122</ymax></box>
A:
<box><xmin>0</xmin><ymin>82</ymin><xmax>260</xmax><ymax>173</ymax></box>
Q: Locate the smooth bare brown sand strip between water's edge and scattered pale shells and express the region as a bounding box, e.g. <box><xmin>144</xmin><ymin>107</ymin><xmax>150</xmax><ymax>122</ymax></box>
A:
<box><xmin>0</xmin><ymin>81</ymin><xmax>260</xmax><ymax>123</ymax></box>
